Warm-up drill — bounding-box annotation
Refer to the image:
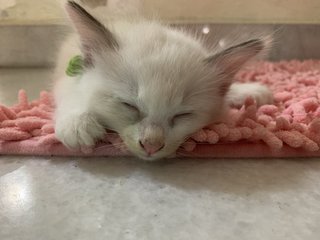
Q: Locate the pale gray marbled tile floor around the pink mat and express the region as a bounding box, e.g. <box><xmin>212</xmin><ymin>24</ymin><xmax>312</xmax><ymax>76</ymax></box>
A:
<box><xmin>0</xmin><ymin>69</ymin><xmax>320</xmax><ymax>240</ymax></box>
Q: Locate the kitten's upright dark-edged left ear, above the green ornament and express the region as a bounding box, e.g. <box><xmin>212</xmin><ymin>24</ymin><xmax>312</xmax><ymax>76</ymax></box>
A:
<box><xmin>66</xmin><ymin>1</ymin><xmax>119</xmax><ymax>65</ymax></box>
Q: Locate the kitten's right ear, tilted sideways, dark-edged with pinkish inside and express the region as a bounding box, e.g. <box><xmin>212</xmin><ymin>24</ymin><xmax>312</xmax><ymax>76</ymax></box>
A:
<box><xmin>205</xmin><ymin>39</ymin><xmax>265</xmax><ymax>95</ymax></box>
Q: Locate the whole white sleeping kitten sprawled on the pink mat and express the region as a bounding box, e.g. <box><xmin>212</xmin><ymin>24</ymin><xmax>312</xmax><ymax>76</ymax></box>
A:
<box><xmin>55</xmin><ymin>1</ymin><xmax>272</xmax><ymax>160</ymax></box>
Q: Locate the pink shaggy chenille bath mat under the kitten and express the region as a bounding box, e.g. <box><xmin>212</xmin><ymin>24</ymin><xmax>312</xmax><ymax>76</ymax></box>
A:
<box><xmin>0</xmin><ymin>60</ymin><xmax>320</xmax><ymax>158</ymax></box>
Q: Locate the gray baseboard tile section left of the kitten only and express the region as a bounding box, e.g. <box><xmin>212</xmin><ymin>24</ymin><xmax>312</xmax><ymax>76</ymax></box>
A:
<box><xmin>0</xmin><ymin>25</ymin><xmax>68</xmax><ymax>67</ymax></box>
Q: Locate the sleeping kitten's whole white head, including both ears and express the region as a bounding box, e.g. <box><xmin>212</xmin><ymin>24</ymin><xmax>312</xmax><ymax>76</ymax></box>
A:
<box><xmin>67</xmin><ymin>2</ymin><xmax>264</xmax><ymax>160</ymax></box>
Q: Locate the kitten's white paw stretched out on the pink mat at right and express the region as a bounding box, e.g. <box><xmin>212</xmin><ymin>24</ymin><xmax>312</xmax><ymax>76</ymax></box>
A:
<box><xmin>227</xmin><ymin>83</ymin><xmax>273</xmax><ymax>107</ymax></box>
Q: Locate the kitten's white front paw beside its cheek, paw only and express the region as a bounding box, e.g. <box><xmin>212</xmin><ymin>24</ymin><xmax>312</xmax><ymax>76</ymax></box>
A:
<box><xmin>55</xmin><ymin>113</ymin><xmax>105</xmax><ymax>149</ymax></box>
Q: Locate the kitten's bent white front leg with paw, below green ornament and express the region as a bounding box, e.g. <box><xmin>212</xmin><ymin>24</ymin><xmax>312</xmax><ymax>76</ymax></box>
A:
<box><xmin>55</xmin><ymin>80</ymin><xmax>105</xmax><ymax>148</ymax></box>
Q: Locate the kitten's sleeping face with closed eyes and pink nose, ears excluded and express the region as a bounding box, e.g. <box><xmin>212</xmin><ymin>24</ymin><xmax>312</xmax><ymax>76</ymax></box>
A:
<box><xmin>89</xmin><ymin>38</ymin><xmax>224</xmax><ymax>160</ymax></box>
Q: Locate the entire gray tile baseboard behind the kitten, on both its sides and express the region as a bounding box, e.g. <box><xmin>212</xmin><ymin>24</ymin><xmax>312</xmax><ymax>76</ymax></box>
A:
<box><xmin>0</xmin><ymin>24</ymin><xmax>320</xmax><ymax>67</ymax></box>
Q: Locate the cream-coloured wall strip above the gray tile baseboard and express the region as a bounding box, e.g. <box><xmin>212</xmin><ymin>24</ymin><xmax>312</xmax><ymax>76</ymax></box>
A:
<box><xmin>0</xmin><ymin>0</ymin><xmax>320</xmax><ymax>24</ymax></box>
